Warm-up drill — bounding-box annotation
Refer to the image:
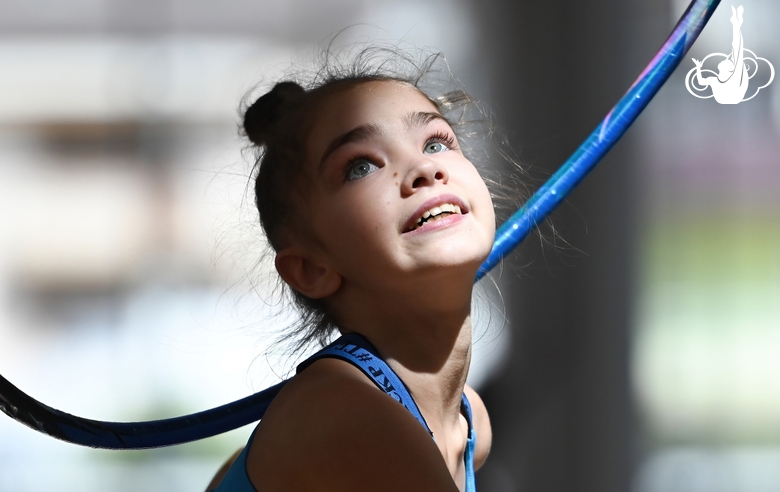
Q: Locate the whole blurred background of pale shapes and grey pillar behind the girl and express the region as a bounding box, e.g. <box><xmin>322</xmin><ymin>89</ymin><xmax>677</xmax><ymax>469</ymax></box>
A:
<box><xmin>0</xmin><ymin>0</ymin><xmax>780</xmax><ymax>492</ymax></box>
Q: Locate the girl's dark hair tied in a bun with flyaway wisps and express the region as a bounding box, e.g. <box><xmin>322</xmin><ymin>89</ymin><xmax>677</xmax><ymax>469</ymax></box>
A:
<box><xmin>243</xmin><ymin>47</ymin><xmax>528</xmax><ymax>348</ymax></box>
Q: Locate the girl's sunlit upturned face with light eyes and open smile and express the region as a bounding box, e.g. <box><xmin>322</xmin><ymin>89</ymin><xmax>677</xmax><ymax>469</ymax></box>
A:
<box><xmin>298</xmin><ymin>81</ymin><xmax>495</xmax><ymax>290</ymax></box>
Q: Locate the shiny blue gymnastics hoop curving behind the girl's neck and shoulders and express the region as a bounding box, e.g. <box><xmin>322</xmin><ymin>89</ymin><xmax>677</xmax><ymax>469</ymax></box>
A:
<box><xmin>0</xmin><ymin>0</ymin><xmax>720</xmax><ymax>449</ymax></box>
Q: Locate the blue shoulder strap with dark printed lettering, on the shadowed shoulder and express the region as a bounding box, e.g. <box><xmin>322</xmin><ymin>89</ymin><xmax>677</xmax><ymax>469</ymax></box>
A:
<box><xmin>297</xmin><ymin>333</ymin><xmax>432</xmax><ymax>436</ymax></box>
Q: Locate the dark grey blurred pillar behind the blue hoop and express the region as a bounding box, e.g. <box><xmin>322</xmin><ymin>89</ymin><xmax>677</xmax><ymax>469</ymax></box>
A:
<box><xmin>470</xmin><ymin>0</ymin><xmax>668</xmax><ymax>492</ymax></box>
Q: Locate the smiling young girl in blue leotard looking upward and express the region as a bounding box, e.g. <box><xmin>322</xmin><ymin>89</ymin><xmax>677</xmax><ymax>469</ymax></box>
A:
<box><xmin>208</xmin><ymin>51</ymin><xmax>495</xmax><ymax>492</ymax></box>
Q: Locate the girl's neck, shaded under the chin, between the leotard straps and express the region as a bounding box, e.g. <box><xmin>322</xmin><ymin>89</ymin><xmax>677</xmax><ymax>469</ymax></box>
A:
<box><xmin>334</xmin><ymin>270</ymin><xmax>473</xmax><ymax>425</ymax></box>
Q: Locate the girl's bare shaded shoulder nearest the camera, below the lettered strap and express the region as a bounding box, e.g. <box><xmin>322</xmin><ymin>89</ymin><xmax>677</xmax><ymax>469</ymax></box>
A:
<box><xmin>247</xmin><ymin>359</ymin><xmax>460</xmax><ymax>492</ymax></box>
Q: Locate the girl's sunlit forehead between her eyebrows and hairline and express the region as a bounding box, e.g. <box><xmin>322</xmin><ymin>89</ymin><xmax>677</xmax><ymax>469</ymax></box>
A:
<box><xmin>308</xmin><ymin>81</ymin><xmax>439</xmax><ymax>150</ymax></box>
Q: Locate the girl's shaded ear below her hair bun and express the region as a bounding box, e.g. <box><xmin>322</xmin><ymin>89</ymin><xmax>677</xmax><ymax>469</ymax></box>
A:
<box><xmin>275</xmin><ymin>246</ymin><xmax>341</xmax><ymax>299</ymax></box>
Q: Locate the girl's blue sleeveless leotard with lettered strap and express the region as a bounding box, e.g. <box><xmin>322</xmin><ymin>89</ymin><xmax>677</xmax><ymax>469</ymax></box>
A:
<box><xmin>212</xmin><ymin>333</ymin><xmax>477</xmax><ymax>492</ymax></box>
